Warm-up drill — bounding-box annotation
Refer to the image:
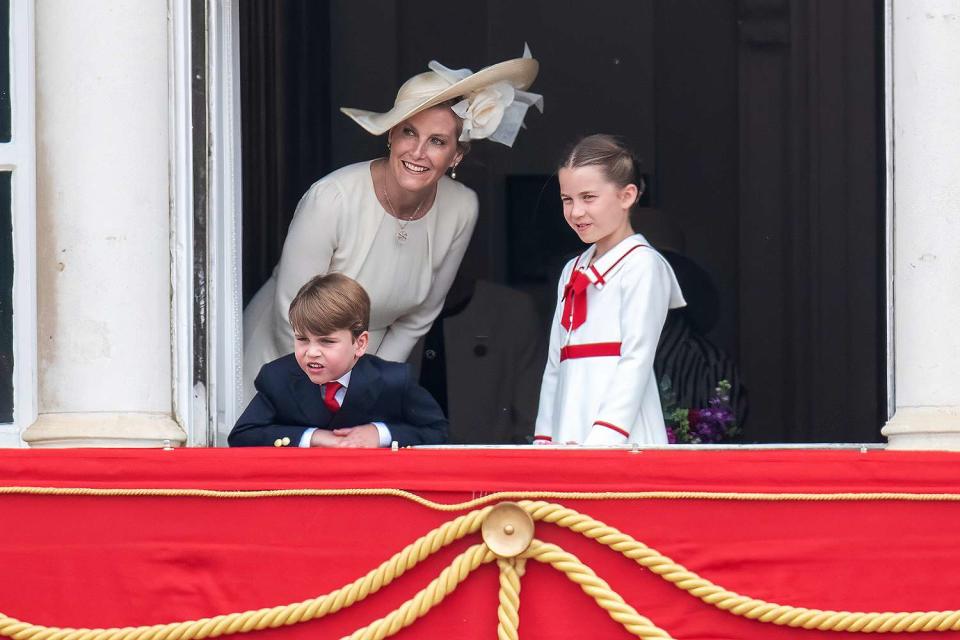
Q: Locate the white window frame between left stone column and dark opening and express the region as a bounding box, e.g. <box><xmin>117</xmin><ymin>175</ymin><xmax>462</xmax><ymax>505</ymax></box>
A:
<box><xmin>169</xmin><ymin>0</ymin><xmax>243</xmax><ymax>447</ymax></box>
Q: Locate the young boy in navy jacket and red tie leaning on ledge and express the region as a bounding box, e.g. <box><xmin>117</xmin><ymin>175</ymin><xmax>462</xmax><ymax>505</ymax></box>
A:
<box><xmin>228</xmin><ymin>273</ymin><xmax>448</xmax><ymax>447</ymax></box>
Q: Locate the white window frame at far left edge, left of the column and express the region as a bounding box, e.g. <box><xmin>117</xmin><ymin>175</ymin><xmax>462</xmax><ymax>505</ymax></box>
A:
<box><xmin>0</xmin><ymin>0</ymin><xmax>37</xmax><ymax>447</ymax></box>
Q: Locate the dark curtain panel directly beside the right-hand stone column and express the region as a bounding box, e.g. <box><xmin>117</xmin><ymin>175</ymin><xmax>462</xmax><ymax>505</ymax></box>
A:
<box><xmin>739</xmin><ymin>0</ymin><xmax>886</xmax><ymax>442</ymax></box>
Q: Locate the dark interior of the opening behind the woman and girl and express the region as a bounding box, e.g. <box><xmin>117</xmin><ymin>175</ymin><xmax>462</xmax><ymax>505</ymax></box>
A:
<box><xmin>240</xmin><ymin>0</ymin><xmax>886</xmax><ymax>442</ymax></box>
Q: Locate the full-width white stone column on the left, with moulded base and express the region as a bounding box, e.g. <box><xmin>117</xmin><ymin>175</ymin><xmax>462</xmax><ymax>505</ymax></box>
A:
<box><xmin>23</xmin><ymin>0</ymin><xmax>185</xmax><ymax>447</ymax></box>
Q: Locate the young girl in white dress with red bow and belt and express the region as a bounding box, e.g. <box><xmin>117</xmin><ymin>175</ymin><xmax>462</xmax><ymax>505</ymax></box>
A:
<box><xmin>534</xmin><ymin>135</ymin><xmax>686</xmax><ymax>445</ymax></box>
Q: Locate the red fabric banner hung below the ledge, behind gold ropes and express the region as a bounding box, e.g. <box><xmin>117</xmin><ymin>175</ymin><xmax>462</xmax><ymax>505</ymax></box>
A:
<box><xmin>0</xmin><ymin>448</ymin><xmax>960</xmax><ymax>640</ymax></box>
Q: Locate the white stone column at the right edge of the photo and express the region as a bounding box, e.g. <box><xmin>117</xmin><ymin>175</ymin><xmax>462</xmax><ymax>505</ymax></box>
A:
<box><xmin>883</xmin><ymin>0</ymin><xmax>960</xmax><ymax>449</ymax></box>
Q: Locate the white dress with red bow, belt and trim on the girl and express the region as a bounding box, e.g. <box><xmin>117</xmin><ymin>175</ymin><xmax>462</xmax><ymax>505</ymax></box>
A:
<box><xmin>535</xmin><ymin>234</ymin><xmax>686</xmax><ymax>445</ymax></box>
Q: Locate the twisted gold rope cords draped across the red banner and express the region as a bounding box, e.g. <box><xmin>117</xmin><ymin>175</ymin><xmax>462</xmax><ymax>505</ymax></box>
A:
<box><xmin>0</xmin><ymin>487</ymin><xmax>960</xmax><ymax>640</ymax></box>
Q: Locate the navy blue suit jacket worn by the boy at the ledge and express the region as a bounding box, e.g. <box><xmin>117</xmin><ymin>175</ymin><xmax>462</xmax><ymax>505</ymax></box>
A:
<box><xmin>228</xmin><ymin>353</ymin><xmax>448</xmax><ymax>447</ymax></box>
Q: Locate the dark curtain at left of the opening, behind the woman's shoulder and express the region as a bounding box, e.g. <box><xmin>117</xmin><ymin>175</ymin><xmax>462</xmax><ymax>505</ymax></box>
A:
<box><xmin>240</xmin><ymin>0</ymin><xmax>330</xmax><ymax>304</ymax></box>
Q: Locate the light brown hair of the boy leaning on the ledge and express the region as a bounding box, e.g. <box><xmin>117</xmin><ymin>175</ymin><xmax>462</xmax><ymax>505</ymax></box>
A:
<box><xmin>287</xmin><ymin>273</ymin><xmax>370</xmax><ymax>339</ymax></box>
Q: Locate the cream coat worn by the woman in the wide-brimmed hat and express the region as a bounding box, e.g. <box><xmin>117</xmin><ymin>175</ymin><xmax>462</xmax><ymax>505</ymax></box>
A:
<box><xmin>243</xmin><ymin>162</ymin><xmax>478</xmax><ymax>399</ymax></box>
